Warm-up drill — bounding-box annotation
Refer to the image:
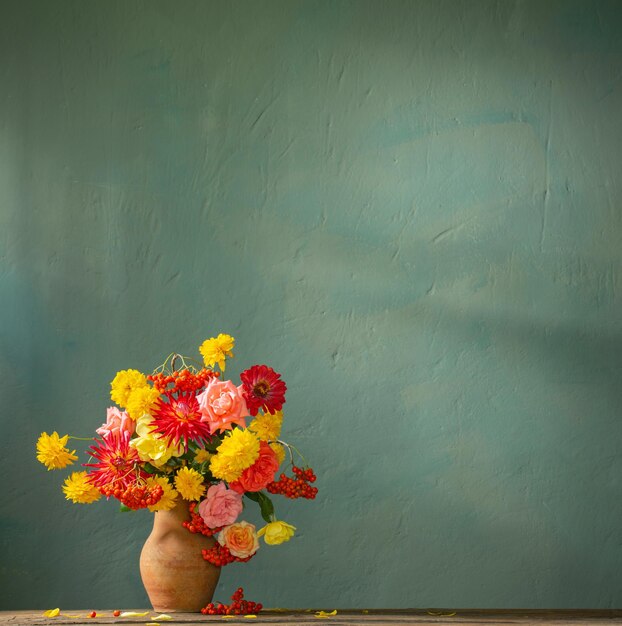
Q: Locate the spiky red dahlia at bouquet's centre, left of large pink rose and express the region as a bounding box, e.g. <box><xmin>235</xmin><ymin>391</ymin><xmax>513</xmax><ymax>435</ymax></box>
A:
<box><xmin>153</xmin><ymin>391</ymin><xmax>211</xmax><ymax>447</ymax></box>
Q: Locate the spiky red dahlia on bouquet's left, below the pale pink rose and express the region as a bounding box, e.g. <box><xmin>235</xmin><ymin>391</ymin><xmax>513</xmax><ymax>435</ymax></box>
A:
<box><xmin>84</xmin><ymin>432</ymin><xmax>146</xmax><ymax>490</ymax></box>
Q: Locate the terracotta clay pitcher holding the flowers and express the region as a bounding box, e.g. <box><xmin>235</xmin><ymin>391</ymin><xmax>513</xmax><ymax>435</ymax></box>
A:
<box><xmin>140</xmin><ymin>500</ymin><xmax>220</xmax><ymax>613</ymax></box>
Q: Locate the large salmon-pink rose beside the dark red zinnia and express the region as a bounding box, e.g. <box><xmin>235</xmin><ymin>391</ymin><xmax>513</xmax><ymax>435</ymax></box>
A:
<box><xmin>197</xmin><ymin>379</ymin><xmax>248</xmax><ymax>432</ymax></box>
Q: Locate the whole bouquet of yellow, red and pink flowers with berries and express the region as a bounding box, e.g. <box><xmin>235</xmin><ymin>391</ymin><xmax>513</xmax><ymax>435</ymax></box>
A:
<box><xmin>37</xmin><ymin>334</ymin><xmax>317</xmax><ymax>566</ymax></box>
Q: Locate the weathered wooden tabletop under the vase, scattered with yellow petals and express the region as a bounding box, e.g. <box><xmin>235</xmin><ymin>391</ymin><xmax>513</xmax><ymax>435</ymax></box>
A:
<box><xmin>0</xmin><ymin>607</ymin><xmax>622</xmax><ymax>626</ymax></box>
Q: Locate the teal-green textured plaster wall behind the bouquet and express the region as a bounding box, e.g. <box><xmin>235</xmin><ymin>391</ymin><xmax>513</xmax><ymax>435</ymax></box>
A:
<box><xmin>0</xmin><ymin>0</ymin><xmax>622</xmax><ymax>609</ymax></box>
